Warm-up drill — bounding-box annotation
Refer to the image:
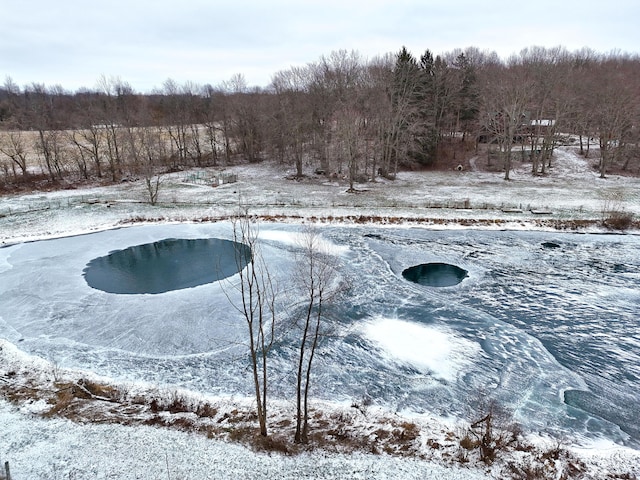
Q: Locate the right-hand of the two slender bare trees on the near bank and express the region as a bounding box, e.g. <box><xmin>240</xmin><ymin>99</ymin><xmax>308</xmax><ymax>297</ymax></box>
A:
<box><xmin>294</xmin><ymin>227</ymin><xmax>338</xmax><ymax>443</ymax></box>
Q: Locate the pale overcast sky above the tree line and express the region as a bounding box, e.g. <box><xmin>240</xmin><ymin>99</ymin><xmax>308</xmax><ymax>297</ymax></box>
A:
<box><xmin>0</xmin><ymin>0</ymin><xmax>640</xmax><ymax>92</ymax></box>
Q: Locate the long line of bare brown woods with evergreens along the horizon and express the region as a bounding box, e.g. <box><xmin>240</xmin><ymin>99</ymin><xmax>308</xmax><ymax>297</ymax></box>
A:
<box><xmin>0</xmin><ymin>47</ymin><xmax>640</xmax><ymax>189</ymax></box>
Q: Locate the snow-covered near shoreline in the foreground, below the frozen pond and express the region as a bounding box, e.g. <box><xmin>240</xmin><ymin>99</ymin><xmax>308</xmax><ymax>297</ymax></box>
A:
<box><xmin>0</xmin><ymin>341</ymin><xmax>640</xmax><ymax>480</ymax></box>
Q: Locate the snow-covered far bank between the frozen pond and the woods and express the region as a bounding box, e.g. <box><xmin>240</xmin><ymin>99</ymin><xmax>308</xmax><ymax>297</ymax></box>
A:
<box><xmin>0</xmin><ymin>147</ymin><xmax>640</xmax><ymax>245</ymax></box>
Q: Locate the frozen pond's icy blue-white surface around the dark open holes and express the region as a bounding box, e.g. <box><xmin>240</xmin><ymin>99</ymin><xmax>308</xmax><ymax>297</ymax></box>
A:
<box><xmin>0</xmin><ymin>223</ymin><xmax>640</xmax><ymax>448</ymax></box>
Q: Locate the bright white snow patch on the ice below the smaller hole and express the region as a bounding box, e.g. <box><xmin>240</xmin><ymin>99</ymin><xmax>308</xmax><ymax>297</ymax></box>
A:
<box><xmin>364</xmin><ymin>318</ymin><xmax>480</xmax><ymax>382</ymax></box>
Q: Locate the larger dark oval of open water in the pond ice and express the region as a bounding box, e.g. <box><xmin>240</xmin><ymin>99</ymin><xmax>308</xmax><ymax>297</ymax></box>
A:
<box><xmin>83</xmin><ymin>238</ymin><xmax>251</xmax><ymax>294</ymax></box>
